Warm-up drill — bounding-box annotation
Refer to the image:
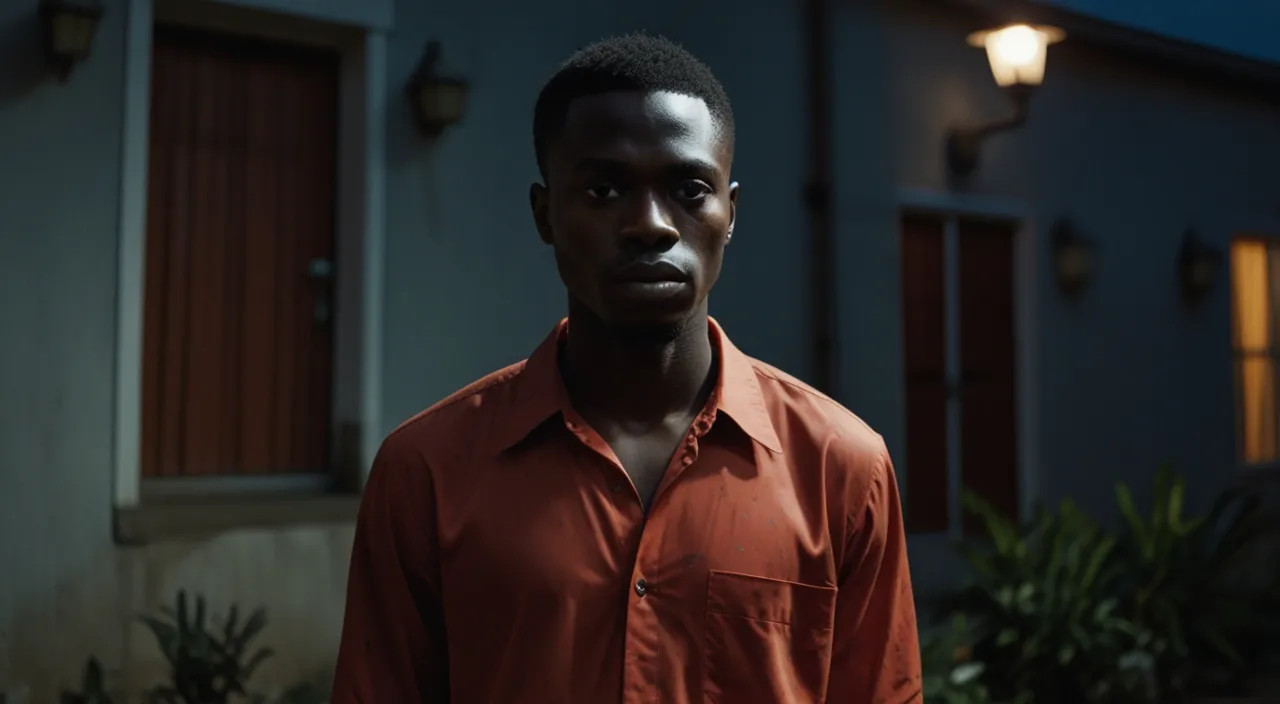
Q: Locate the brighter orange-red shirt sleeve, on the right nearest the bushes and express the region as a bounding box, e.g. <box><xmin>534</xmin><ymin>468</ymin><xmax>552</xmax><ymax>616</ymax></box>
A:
<box><xmin>827</xmin><ymin>451</ymin><xmax>923</xmax><ymax>704</ymax></box>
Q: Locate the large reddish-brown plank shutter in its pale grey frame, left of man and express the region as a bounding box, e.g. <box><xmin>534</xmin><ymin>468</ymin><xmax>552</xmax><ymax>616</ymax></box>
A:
<box><xmin>113</xmin><ymin>0</ymin><xmax>388</xmax><ymax>544</ymax></box>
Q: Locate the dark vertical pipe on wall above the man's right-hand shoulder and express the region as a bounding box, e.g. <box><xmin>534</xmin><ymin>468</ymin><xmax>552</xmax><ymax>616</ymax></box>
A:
<box><xmin>804</xmin><ymin>0</ymin><xmax>836</xmax><ymax>394</ymax></box>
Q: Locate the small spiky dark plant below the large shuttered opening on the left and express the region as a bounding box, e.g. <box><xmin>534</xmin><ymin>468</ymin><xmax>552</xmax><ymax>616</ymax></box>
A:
<box><xmin>141</xmin><ymin>591</ymin><xmax>271</xmax><ymax>704</ymax></box>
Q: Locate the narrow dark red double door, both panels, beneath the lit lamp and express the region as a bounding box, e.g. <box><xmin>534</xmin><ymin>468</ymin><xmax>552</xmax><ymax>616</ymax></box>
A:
<box><xmin>901</xmin><ymin>215</ymin><xmax>1019</xmax><ymax>532</ymax></box>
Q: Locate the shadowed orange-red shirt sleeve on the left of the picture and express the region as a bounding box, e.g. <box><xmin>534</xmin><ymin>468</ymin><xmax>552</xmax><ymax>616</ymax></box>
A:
<box><xmin>332</xmin><ymin>435</ymin><xmax>449</xmax><ymax>704</ymax></box>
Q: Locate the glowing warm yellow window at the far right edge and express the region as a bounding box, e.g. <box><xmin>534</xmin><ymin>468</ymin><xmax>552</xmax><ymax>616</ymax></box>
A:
<box><xmin>1231</xmin><ymin>239</ymin><xmax>1280</xmax><ymax>462</ymax></box>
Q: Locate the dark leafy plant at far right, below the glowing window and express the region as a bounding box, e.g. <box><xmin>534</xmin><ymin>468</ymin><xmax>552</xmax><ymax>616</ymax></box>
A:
<box><xmin>1115</xmin><ymin>467</ymin><xmax>1275</xmax><ymax>695</ymax></box>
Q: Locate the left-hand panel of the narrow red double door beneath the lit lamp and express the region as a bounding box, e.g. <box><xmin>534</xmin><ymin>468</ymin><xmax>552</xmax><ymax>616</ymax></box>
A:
<box><xmin>901</xmin><ymin>216</ymin><xmax>948</xmax><ymax>532</ymax></box>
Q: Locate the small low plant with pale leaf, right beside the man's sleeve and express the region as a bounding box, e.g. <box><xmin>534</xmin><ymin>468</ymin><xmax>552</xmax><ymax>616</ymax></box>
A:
<box><xmin>920</xmin><ymin>613</ymin><xmax>991</xmax><ymax>704</ymax></box>
